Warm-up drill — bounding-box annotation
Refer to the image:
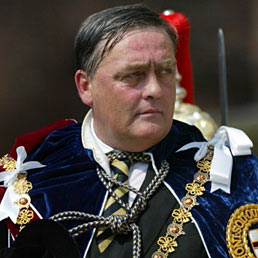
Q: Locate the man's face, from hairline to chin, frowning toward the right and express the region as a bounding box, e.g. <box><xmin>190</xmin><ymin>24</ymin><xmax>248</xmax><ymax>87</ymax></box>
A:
<box><xmin>77</xmin><ymin>27</ymin><xmax>176</xmax><ymax>152</ymax></box>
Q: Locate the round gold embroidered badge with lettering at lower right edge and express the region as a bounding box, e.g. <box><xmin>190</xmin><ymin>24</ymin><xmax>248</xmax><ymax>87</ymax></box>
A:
<box><xmin>226</xmin><ymin>204</ymin><xmax>258</xmax><ymax>258</ymax></box>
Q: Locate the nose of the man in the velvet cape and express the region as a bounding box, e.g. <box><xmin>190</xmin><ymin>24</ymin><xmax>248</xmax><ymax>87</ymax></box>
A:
<box><xmin>143</xmin><ymin>74</ymin><xmax>162</xmax><ymax>99</ymax></box>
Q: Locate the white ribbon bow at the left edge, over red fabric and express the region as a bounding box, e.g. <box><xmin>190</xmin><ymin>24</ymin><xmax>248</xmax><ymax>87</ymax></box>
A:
<box><xmin>0</xmin><ymin>146</ymin><xmax>45</xmax><ymax>223</ymax></box>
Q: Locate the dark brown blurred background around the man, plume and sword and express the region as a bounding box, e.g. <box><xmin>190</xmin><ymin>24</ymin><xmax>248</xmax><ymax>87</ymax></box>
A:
<box><xmin>0</xmin><ymin>0</ymin><xmax>258</xmax><ymax>154</ymax></box>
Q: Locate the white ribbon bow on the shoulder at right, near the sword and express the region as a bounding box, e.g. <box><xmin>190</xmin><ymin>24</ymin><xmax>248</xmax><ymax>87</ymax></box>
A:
<box><xmin>177</xmin><ymin>126</ymin><xmax>253</xmax><ymax>193</ymax></box>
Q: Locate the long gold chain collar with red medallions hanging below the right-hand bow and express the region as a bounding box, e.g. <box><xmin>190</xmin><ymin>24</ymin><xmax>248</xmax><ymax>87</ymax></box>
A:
<box><xmin>152</xmin><ymin>146</ymin><xmax>214</xmax><ymax>258</ymax></box>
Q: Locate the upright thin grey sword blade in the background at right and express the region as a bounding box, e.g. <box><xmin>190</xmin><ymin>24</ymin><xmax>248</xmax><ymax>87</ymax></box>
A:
<box><xmin>218</xmin><ymin>28</ymin><xmax>228</xmax><ymax>125</ymax></box>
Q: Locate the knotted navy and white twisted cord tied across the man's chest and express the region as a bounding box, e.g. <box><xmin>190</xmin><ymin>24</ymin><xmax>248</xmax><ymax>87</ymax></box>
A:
<box><xmin>49</xmin><ymin>157</ymin><xmax>169</xmax><ymax>258</ymax></box>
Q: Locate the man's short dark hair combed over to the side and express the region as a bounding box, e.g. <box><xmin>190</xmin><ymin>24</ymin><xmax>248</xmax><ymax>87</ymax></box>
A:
<box><xmin>75</xmin><ymin>4</ymin><xmax>177</xmax><ymax>77</ymax></box>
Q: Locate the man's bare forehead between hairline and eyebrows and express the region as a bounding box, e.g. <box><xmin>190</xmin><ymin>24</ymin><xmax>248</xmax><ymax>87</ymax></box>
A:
<box><xmin>93</xmin><ymin>27</ymin><xmax>176</xmax><ymax>74</ymax></box>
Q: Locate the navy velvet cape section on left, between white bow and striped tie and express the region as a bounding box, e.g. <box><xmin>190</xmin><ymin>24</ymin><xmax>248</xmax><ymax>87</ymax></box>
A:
<box><xmin>27</xmin><ymin>124</ymin><xmax>105</xmax><ymax>253</ymax></box>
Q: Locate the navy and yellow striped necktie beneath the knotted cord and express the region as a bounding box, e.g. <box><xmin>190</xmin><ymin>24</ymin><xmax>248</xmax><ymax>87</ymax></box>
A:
<box><xmin>96</xmin><ymin>152</ymin><xmax>132</xmax><ymax>253</ymax></box>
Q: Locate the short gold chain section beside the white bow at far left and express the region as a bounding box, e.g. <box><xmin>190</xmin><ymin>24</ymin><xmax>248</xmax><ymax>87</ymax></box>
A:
<box><xmin>0</xmin><ymin>154</ymin><xmax>34</xmax><ymax>230</ymax></box>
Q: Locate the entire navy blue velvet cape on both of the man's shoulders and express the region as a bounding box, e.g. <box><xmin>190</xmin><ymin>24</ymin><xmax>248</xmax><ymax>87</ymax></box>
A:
<box><xmin>24</xmin><ymin>121</ymin><xmax>258</xmax><ymax>258</ymax></box>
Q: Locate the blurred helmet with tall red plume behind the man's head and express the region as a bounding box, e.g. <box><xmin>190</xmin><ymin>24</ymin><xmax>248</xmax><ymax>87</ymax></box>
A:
<box><xmin>160</xmin><ymin>9</ymin><xmax>218</xmax><ymax>140</ymax></box>
